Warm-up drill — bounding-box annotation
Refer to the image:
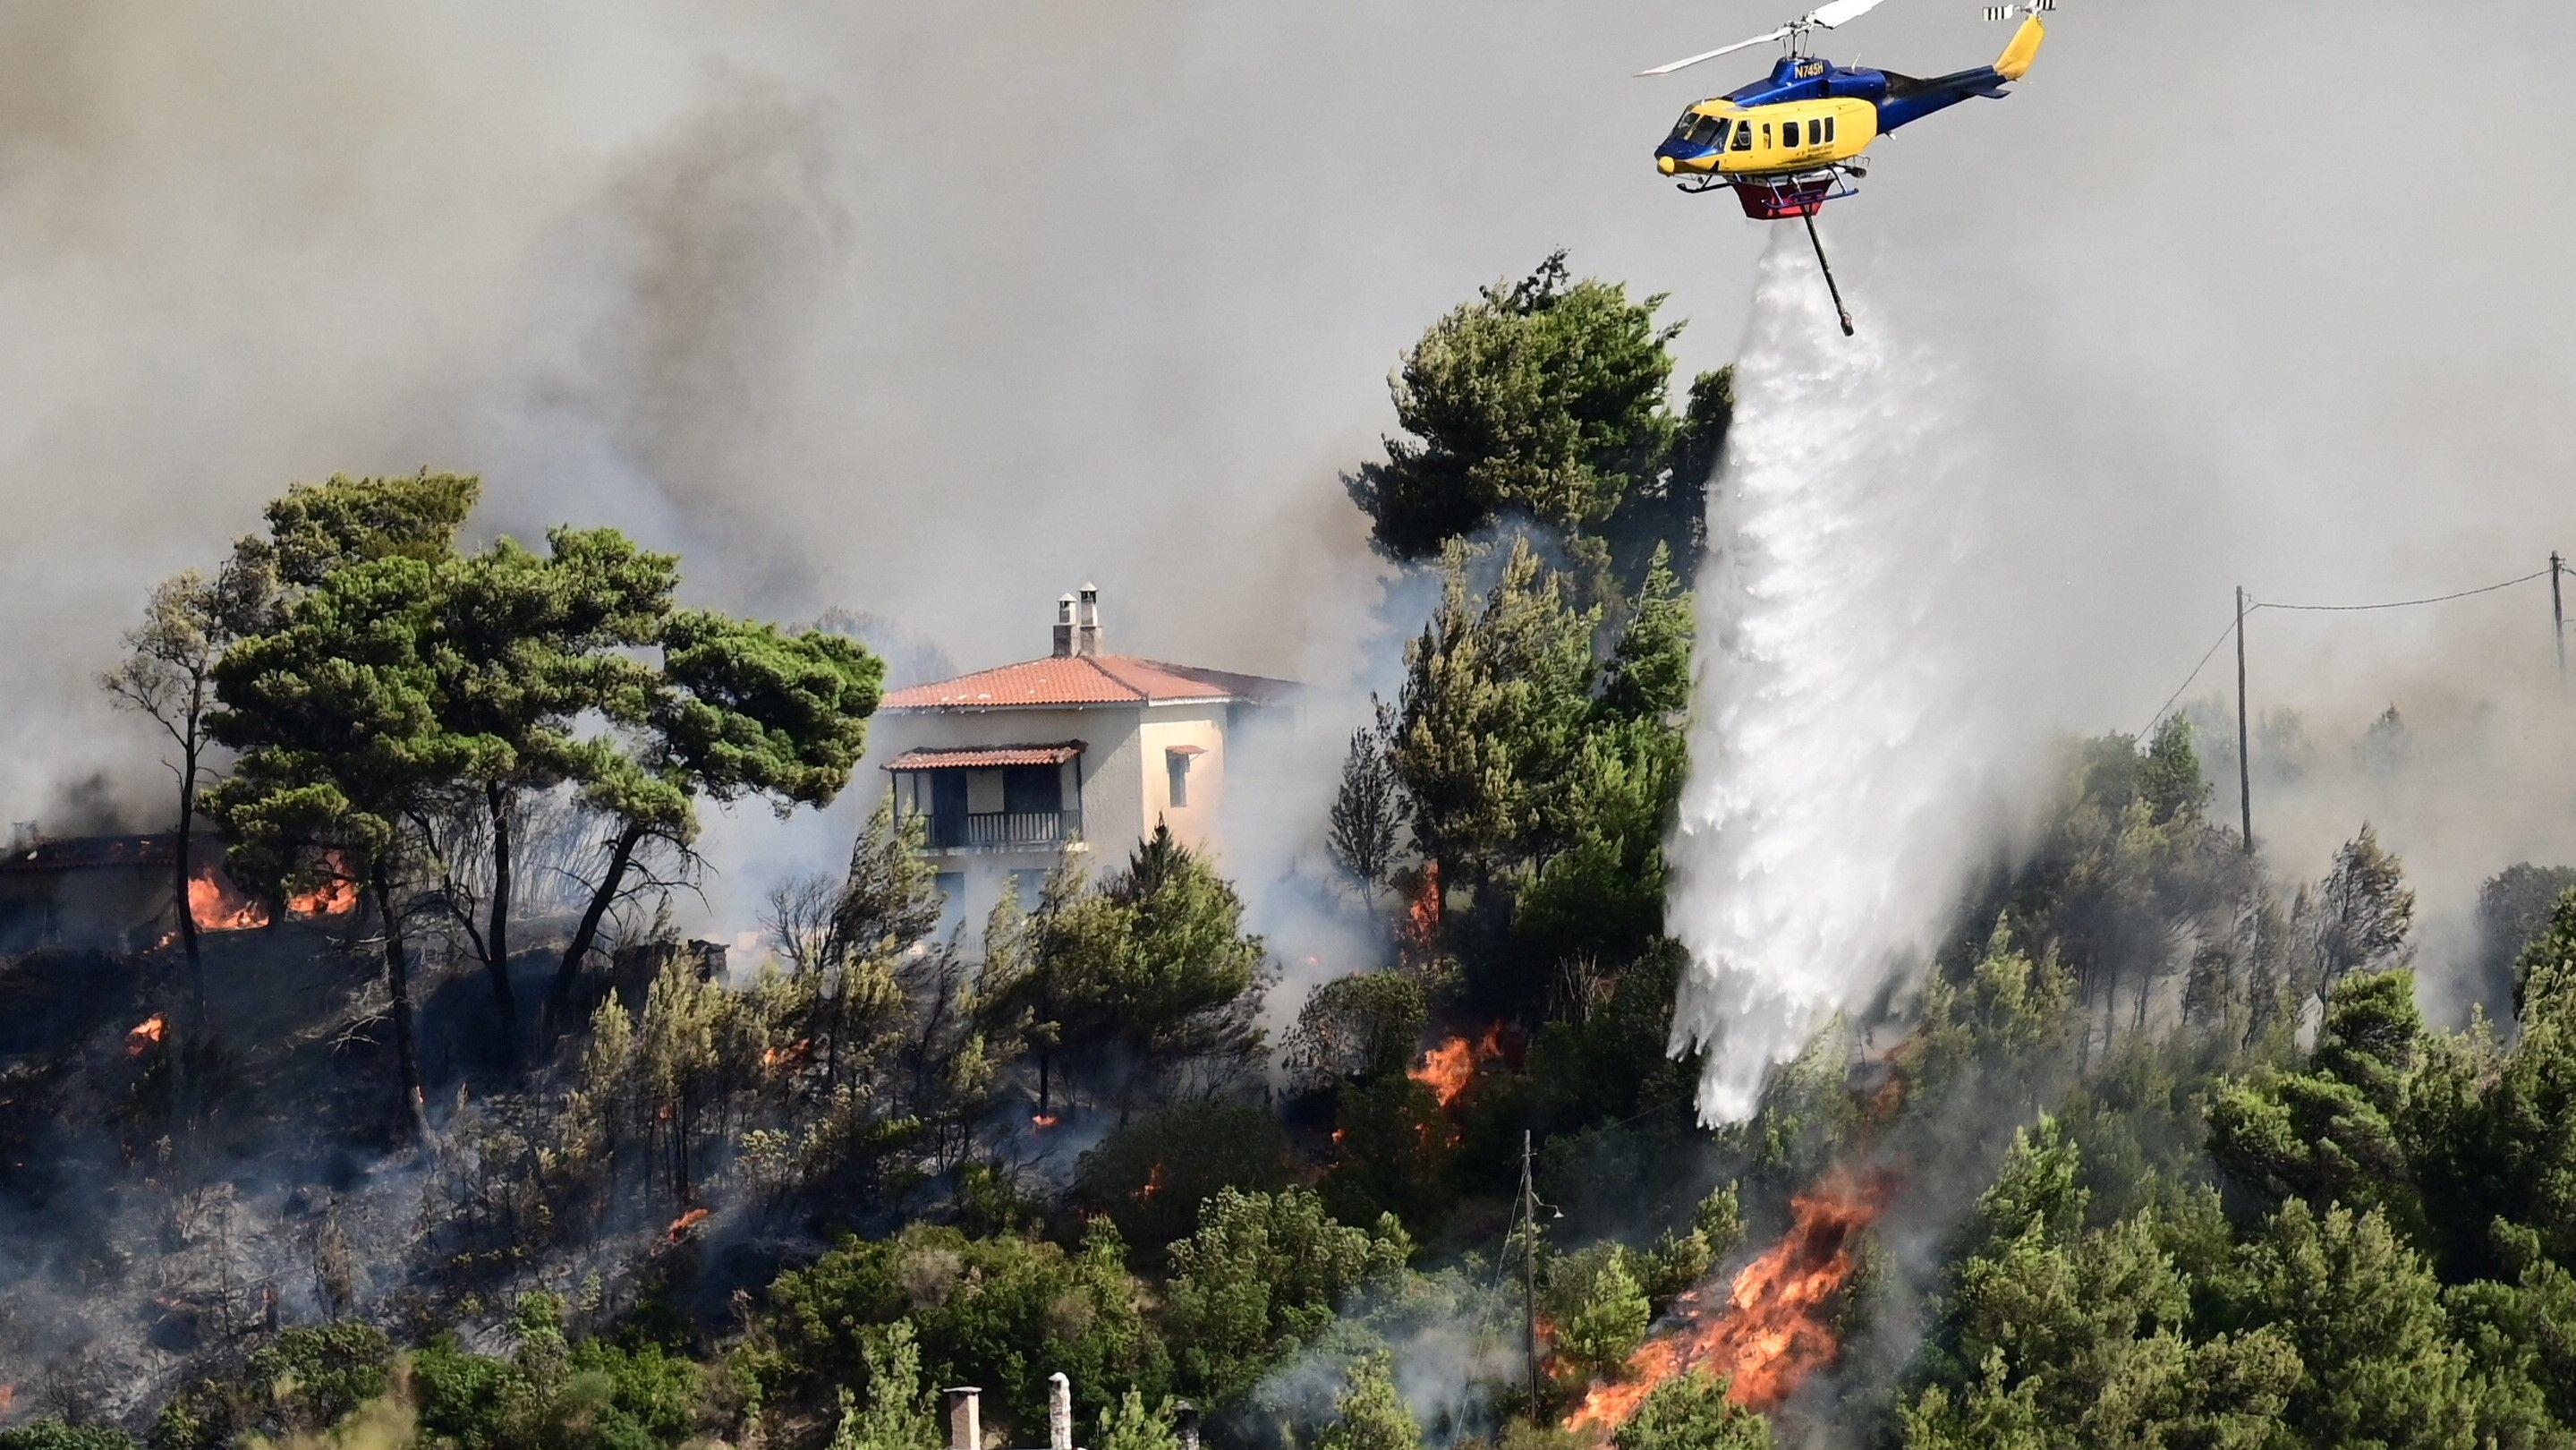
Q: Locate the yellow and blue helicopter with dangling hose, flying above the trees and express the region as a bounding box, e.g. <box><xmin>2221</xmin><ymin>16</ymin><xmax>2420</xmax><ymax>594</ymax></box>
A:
<box><xmin>1638</xmin><ymin>0</ymin><xmax>2058</xmax><ymax>337</ymax></box>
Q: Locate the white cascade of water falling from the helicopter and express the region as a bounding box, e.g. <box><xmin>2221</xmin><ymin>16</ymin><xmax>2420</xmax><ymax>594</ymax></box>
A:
<box><xmin>1670</xmin><ymin>226</ymin><xmax>2002</xmax><ymax>1123</ymax></box>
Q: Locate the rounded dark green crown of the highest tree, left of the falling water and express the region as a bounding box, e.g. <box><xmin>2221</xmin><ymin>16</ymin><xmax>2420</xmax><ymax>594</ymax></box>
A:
<box><xmin>1345</xmin><ymin>252</ymin><xmax>1705</xmax><ymax>559</ymax></box>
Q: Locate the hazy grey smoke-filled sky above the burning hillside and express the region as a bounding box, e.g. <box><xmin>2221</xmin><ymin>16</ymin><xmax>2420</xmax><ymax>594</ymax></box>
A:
<box><xmin>0</xmin><ymin>0</ymin><xmax>2576</xmax><ymax>917</ymax></box>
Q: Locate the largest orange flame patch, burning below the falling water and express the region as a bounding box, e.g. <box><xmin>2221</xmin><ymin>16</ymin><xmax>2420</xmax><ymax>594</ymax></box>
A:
<box><xmin>1566</xmin><ymin>1169</ymin><xmax>1891</xmax><ymax>1437</ymax></box>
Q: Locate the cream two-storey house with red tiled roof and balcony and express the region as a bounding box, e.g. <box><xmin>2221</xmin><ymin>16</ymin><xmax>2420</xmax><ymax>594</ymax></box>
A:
<box><xmin>871</xmin><ymin>584</ymin><xmax>1298</xmax><ymax>930</ymax></box>
